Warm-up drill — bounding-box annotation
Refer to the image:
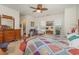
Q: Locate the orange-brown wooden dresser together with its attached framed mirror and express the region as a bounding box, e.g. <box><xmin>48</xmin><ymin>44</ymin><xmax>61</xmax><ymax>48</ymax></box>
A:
<box><xmin>0</xmin><ymin>14</ymin><xmax>21</xmax><ymax>42</ymax></box>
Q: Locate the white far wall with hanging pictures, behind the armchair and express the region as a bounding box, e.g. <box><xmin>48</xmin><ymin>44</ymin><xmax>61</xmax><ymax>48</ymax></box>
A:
<box><xmin>21</xmin><ymin>13</ymin><xmax>64</xmax><ymax>34</ymax></box>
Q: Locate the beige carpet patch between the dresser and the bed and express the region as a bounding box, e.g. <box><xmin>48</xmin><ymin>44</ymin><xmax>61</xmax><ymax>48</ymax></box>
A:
<box><xmin>7</xmin><ymin>40</ymin><xmax>22</xmax><ymax>55</ymax></box>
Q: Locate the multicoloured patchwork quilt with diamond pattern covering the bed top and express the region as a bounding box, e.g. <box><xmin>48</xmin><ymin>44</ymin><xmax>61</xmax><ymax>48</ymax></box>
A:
<box><xmin>24</xmin><ymin>36</ymin><xmax>79</xmax><ymax>55</ymax></box>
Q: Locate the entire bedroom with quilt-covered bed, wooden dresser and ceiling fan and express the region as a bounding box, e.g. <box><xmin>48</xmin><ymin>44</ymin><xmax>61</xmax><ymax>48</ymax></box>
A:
<box><xmin>0</xmin><ymin>4</ymin><xmax>79</xmax><ymax>55</ymax></box>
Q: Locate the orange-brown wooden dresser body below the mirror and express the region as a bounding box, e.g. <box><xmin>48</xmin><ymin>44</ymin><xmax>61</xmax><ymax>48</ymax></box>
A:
<box><xmin>0</xmin><ymin>29</ymin><xmax>21</xmax><ymax>42</ymax></box>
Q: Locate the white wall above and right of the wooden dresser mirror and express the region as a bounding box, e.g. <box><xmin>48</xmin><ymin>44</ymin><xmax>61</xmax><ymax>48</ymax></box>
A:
<box><xmin>0</xmin><ymin>5</ymin><xmax>20</xmax><ymax>29</ymax></box>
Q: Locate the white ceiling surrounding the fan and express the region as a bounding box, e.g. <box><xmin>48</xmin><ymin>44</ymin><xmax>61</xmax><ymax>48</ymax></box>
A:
<box><xmin>3</xmin><ymin>4</ymin><xmax>76</xmax><ymax>16</ymax></box>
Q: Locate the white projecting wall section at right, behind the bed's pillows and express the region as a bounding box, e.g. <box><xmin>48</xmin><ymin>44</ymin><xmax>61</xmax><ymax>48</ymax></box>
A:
<box><xmin>64</xmin><ymin>7</ymin><xmax>78</xmax><ymax>34</ymax></box>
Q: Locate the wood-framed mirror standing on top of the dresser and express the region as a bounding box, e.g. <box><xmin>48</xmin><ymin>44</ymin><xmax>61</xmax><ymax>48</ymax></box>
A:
<box><xmin>0</xmin><ymin>15</ymin><xmax>15</xmax><ymax>29</ymax></box>
